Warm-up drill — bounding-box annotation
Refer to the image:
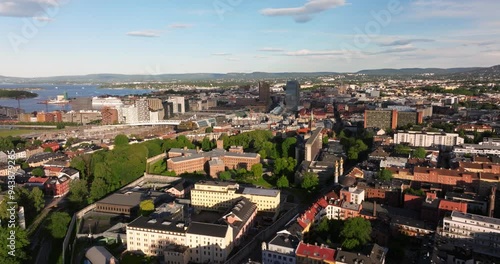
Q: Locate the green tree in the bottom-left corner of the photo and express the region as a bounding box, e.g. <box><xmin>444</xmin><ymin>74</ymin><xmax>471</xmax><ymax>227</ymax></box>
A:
<box><xmin>0</xmin><ymin>226</ymin><xmax>30</xmax><ymax>264</ymax></box>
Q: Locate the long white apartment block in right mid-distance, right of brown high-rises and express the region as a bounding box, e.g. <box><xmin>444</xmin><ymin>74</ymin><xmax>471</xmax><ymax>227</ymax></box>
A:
<box><xmin>394</xmin><ymin>131</ymin><xmax>464</xmax><ymax>147</ymax></box>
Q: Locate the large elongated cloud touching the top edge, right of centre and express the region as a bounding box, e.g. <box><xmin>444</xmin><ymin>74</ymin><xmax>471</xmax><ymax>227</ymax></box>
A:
<box><xmin>260</xmin><ymin>0</ymin><xmax>346</xmax><ymax>23</ymax></box>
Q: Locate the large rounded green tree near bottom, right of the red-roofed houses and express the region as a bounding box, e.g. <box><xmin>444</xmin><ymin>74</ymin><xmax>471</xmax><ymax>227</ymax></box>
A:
<box><xmin>340</xmin><ymin>217</ymin><xmax>372</xmax><ymax>250</ymax></box>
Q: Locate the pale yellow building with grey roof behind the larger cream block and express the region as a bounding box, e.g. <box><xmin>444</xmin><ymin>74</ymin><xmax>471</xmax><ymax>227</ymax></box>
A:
<box><xmin>191</xmin><ymin>181</ymin><xmax>281</xmax><ymax>212</ymax></box>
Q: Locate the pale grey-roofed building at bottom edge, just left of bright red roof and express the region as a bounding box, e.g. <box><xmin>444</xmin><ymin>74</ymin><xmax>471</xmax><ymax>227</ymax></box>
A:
<box><xmin>262</xmin><ymin>230</ymin><xmax>299</xmax><ymax>264</ymax></box>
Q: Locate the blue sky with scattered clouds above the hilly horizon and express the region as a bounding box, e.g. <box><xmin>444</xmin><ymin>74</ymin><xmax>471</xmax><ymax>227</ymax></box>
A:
<box><xmin>0</xmin><ymin>0</ymin><xmax>500</xmax><ymax>77</ymax></box>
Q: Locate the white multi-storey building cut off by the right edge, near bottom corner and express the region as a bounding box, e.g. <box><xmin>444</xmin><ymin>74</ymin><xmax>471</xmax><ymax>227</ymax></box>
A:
<box><xmin>440</xmin><ymin>211</ymin><xmax>500</xmax><ymax>257</ymax></box>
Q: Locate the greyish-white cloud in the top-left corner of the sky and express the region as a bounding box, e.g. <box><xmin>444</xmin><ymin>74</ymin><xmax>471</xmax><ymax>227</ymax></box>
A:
<box><xmin>0</xmin><ymin>0</ymin><xmax>66</xmax><ymax>17</ymax></box>
